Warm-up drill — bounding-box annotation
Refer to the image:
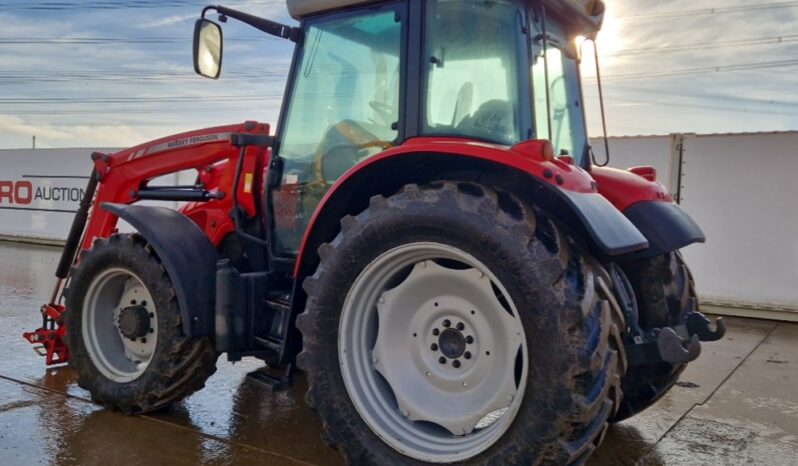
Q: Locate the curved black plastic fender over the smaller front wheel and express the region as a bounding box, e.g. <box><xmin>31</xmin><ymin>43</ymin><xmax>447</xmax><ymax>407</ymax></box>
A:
<box><xmin>100</xmin><ymin>202</ymin><xmax>217</xmax><ymax>337</ymax></box>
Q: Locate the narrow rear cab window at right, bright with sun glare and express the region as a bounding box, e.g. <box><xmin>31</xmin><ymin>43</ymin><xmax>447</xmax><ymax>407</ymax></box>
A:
<box><xmin>531</xmin><ymin>11</ymin><xmax>588</xmax><ymax>165</ymax></box>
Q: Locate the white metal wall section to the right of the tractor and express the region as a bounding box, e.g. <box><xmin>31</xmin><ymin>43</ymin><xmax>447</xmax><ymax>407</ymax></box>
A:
<box><xmin>593</xmin><ymin>132</ymin><xmax>798</xmax><ymax>321</ymax></box>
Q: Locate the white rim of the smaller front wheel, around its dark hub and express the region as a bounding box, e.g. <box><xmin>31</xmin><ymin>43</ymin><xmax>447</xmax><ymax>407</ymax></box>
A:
<box><xmin>81</xmin><ymin>268</ymin><xmax>158</xmax><ymax>383</ymax></box>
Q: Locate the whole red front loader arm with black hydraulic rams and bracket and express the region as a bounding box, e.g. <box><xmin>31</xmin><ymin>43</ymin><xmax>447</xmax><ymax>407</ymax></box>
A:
<box><xmin>23</xmin><ymin>121</ymin><xmax>269</xmax><ymax>366</ymax></box>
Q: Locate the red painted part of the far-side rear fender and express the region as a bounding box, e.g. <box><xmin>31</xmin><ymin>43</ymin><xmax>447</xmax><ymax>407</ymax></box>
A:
<box><xmin>590</xmin><ymin>167</ymin><xmax>673</xmax><ymax>212</ymax></box>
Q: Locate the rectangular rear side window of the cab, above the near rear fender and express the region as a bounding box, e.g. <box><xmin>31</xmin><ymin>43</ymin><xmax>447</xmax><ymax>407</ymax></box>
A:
<box><xmin>422</xmin><ymin>0</ymin><xmax>521</xmax><ymax>144</ymax></box>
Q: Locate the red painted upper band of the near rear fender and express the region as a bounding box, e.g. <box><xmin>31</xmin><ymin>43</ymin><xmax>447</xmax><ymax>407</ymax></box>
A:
<box><xmin>294</xmin><ymin>137</ymin><xmax>596</xmax><ymax>277</ymax></box>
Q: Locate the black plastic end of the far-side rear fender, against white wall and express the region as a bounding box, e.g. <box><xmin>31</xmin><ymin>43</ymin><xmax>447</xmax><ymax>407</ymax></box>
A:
<box><xmin>623</xmin><ymin>201</ymin><xmax>706</xmax><ymax>258</ymax></box>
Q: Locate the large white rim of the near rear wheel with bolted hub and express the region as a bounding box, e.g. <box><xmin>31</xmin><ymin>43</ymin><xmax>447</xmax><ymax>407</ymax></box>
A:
<box><xmin>338</xmin><ymin>242</ymin><xmax>529</xmax><ymax>462</ymax></box>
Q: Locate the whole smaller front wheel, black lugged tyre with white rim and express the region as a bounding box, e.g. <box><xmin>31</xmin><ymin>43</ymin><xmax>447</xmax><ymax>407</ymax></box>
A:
<box><xmin>65</xmin><ymin>234</ymin><xmax>217</xmax><ymax>414</ymax></box>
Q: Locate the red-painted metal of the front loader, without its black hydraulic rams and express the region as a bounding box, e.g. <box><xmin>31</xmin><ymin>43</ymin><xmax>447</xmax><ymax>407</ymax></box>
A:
<box><xmin>23</xmin><ymin>122</ymin><xmax>269</xmax><ymax>366</ymax></box>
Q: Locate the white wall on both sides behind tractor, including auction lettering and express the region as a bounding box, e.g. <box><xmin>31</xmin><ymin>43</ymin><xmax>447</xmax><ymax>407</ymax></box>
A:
<box><xmin>0</xmin><ymin>132</ymin><xmax>798</xmax><ymax>320</ymax></box>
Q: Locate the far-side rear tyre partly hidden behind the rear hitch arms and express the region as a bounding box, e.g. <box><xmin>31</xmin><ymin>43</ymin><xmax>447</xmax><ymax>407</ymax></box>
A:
<box><xmin>613</xmin><ymin>252</ymin><xmax>698</xmax><ymax>422</ymax></box>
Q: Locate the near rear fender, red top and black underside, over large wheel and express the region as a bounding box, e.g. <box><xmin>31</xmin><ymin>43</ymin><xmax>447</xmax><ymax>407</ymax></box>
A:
<box><xmin>294</xmin><ymin>138</ymin><xmax>648</xmax><ymax>278</ymax></box>
